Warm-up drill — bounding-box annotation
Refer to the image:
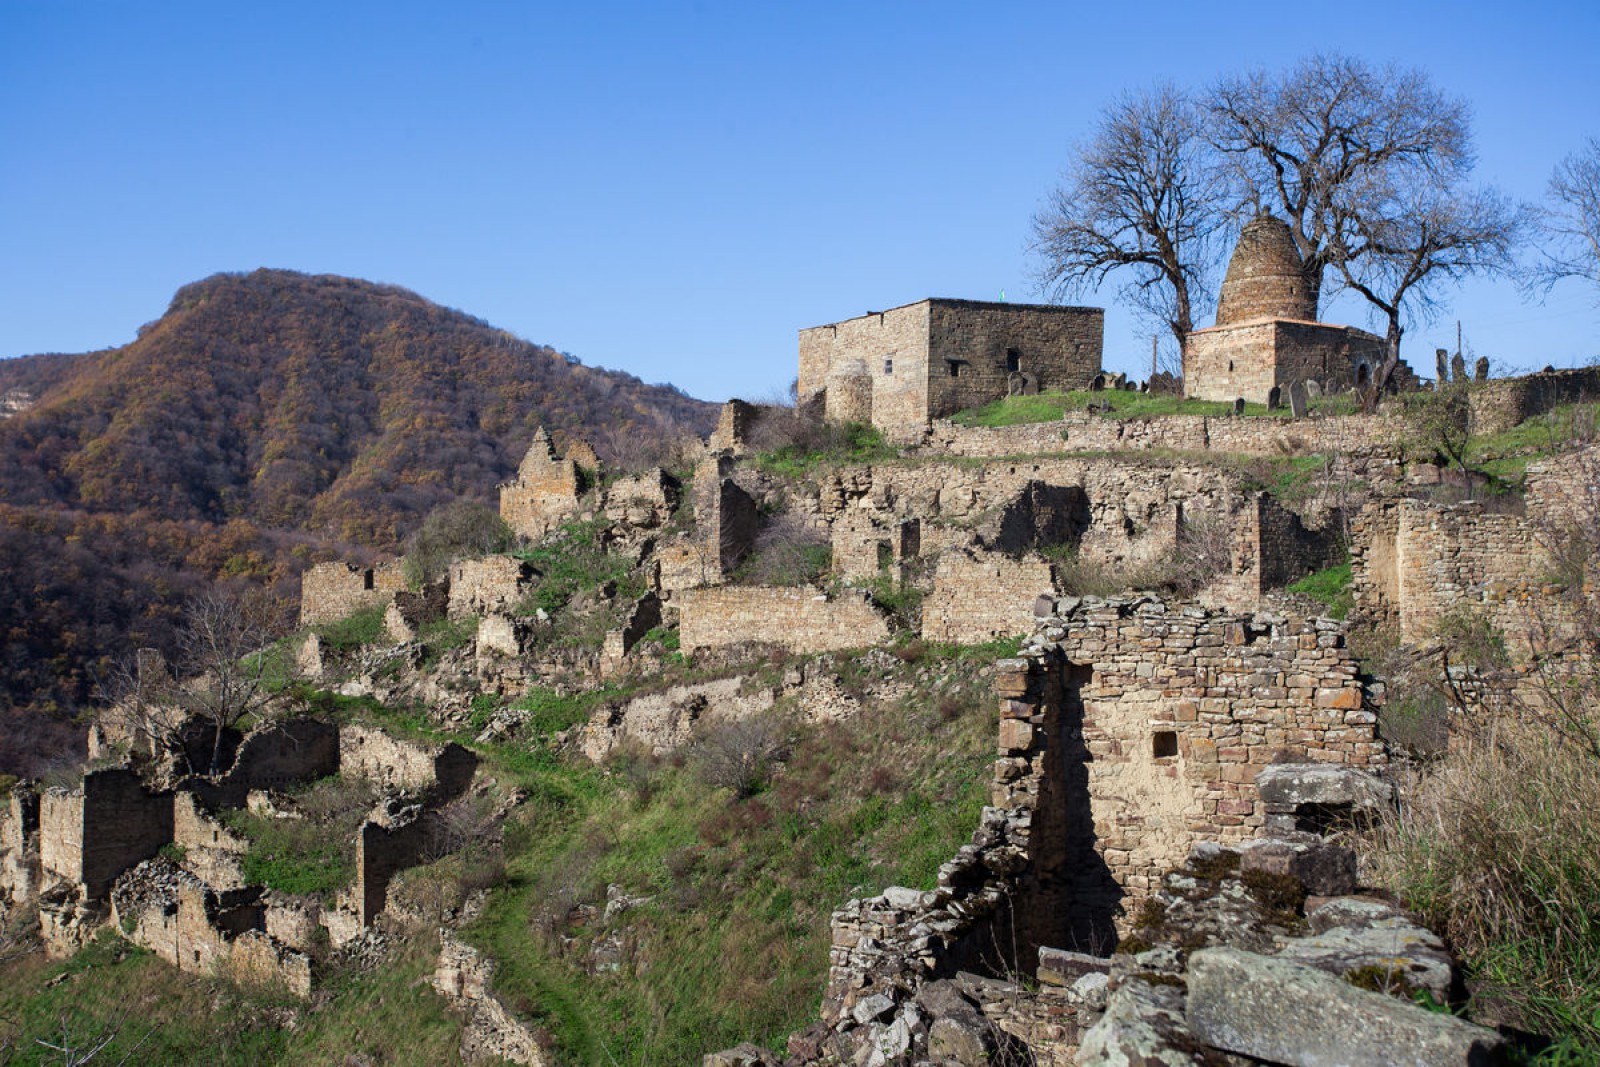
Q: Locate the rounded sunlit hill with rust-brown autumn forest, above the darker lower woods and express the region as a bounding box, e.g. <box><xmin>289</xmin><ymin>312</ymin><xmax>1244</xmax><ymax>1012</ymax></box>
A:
<box><xmin>0</xmin><ymin>270</ymin><xmax>715</xmax><ymax>547</ymax></box>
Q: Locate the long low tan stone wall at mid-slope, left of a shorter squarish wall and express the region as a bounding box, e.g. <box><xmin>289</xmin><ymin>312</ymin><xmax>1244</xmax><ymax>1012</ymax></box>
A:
<box><xmin>674</xmin><ymin>585</ymin><xmax>890</xmax><ymax>653</ymax></box>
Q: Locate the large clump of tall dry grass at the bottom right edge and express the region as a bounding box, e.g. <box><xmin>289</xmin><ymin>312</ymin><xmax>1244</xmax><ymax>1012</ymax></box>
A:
<box><xmin>1365</xmin><ymin>718</ymin><xmax>1600</xmax><ymax>1053</ymax></box>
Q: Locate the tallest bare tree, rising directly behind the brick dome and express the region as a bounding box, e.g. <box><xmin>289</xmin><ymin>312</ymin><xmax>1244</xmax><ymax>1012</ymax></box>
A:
<box><xmin>1206</xmin><ymin>54</ymin><xmax>1472</xmax><ymax>313</ymax></box>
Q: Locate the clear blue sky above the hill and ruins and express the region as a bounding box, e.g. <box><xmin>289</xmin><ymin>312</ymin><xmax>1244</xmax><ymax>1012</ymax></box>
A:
<box><xmin>0</xmin><ymin>0</ymin><xmax>1600</xmax><ymax>400</ymax></box>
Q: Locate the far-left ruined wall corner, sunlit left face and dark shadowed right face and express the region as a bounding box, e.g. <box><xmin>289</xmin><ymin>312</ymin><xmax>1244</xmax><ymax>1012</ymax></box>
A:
<box><xmin>38</xmin><ymin>768</ymin><xmax>173</xmax><ymax>901</ymax></box>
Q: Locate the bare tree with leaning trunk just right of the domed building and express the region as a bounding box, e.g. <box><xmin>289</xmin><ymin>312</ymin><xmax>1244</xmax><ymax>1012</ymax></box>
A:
<box><xmin>1328</xmin><ymin>170</ymin><xmax>1526</xmax><ymax>399</ymax></box>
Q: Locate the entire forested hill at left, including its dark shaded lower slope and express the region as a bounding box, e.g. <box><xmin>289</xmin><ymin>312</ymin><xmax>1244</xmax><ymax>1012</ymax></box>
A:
<box><xmin>0</xmin><ymin>270</ymin><xmax>715</xmax><ymax>742</ymax></box>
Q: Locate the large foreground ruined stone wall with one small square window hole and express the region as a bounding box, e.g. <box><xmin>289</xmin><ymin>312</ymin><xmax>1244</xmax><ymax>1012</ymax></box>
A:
<box><xmin>1024</xmin><ymin>598</ymin><xmax>1386</xmax><ymax>896</ymax></box>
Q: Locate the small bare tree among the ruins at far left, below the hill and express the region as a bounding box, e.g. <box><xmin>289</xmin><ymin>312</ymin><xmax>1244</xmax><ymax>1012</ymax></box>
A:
<box><xmin>178</xmin><ymin>592</ymin><xmax>278</xmax><ymax>774</ymax></box>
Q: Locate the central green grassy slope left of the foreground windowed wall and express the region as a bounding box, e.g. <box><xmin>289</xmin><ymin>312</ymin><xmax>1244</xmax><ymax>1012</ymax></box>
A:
<box><xmin>454</xmin><ymin>655</ymin><xmax>1014</xmax><ymax>1064</ymax></box>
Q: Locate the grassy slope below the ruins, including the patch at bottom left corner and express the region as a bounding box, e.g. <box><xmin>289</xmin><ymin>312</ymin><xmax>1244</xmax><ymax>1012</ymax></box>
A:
<box><xmin>0</xmin><ymin>648</ymin><xmax>1005</xmax><ymax>1064</ymax></box>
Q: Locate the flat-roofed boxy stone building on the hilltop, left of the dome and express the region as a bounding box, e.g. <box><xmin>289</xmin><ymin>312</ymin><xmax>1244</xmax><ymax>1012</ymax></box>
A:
<box><xmin>798</xmin><ymin>299</ymin><xmax>1106</xmax><ymax>440</ymax></box>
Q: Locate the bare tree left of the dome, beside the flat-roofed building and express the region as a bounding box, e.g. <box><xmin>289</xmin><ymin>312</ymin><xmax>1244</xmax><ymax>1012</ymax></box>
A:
<box><xmin>1032</xmin><ymin>85</ymin><xmax>1224</xmax><ymax>349</ymax></box>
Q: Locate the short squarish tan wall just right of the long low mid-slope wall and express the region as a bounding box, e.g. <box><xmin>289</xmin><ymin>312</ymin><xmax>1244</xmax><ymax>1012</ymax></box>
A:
<box><xmin>922</xmin><ymin>552</ymin><xmax>1054</xmax><ymax>645</ymax></box>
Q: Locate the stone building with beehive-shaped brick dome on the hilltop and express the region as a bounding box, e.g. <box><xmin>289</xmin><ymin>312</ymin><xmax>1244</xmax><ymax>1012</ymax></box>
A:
<box><xmin>1184</xmin><ymin>214</ymin><xmax>1386</xmax><ymax>403</ymax></box>
